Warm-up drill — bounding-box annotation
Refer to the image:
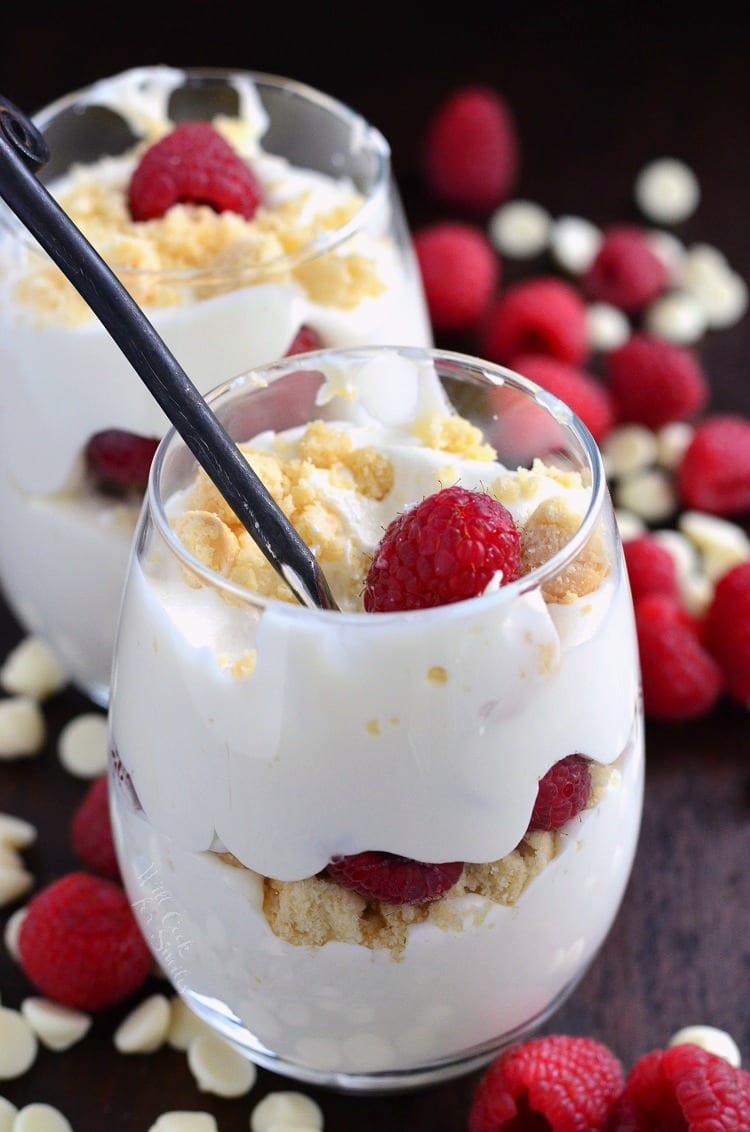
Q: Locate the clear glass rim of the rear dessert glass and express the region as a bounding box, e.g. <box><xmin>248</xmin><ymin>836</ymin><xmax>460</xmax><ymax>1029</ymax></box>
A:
<box><xmin>0</xmin><ymin>65</ymin><xmax>391</xmax><ymax>284</ymax></box>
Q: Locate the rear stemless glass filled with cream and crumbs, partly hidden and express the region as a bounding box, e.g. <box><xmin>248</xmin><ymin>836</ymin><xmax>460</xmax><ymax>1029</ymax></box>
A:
<box><xmin>0</xmin><ymin>67</ymin><xmax>431</xmax><ymax>705</ymax></box>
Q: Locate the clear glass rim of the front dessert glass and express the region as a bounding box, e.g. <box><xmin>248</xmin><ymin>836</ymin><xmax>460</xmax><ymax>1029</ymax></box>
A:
<box><xmin>144</xmin><ymin>345</ymin><xmax>607</xmax><ymax>625</ymax></box>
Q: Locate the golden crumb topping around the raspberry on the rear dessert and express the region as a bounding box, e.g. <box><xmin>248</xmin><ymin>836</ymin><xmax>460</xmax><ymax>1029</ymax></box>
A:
<box><xmin>16</xmin><ymin>135</ymin><xmax>385</xmax><ymax>325</ymax></box>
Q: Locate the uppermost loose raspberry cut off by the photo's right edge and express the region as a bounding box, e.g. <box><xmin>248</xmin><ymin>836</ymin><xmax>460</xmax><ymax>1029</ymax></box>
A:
<box><xmin>675</xmin><ymin>413</ymin><xmax>750</xmax><ymax>515</ymax></box>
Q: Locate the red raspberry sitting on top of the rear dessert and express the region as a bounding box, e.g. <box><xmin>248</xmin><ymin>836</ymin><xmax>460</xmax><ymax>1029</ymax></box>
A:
<box><xmin>128</xmin><ymin>121</ymin><xmax>261</xmax><ymax>221</ymax></box>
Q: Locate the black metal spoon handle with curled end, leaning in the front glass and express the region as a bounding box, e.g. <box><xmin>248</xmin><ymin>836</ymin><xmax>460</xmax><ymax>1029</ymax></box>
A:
<box><xmin>0</xmin><ymin>95</ymin><xmax>337</xmax><ymax>609</ymax></box>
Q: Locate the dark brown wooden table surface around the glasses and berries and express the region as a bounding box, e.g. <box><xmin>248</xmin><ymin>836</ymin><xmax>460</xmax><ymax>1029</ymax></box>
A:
<box><xmin>0</xmin><ymin>2</ymin><xmax>750</xmax><ymax>1132</ymax></box>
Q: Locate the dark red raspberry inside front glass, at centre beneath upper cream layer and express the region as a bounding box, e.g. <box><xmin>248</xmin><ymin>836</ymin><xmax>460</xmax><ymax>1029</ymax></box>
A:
<box><xmin>326</xmin><ymin>852</ymin><xmax>464</xmax><ymax>904</ymax></box>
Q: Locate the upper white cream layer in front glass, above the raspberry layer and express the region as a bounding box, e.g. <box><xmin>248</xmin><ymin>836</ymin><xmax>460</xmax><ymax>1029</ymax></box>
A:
<box><xmin>111</xmin><ymin>359</ymin><xmax>638</xmax><ymax>881</ymax></box>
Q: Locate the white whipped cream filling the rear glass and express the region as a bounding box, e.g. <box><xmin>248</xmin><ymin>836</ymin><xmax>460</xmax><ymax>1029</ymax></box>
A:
<box><xmin>0</xmin><ymin>67</ymin><xmax>431</xmax><ymax>700</ymax></box>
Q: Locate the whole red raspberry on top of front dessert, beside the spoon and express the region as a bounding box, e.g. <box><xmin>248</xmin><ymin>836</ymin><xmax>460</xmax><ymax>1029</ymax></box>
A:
<box><xmin>364</xmin><ymin>487</ymin><xmax>520</xmax><ymax>612</ymax></box>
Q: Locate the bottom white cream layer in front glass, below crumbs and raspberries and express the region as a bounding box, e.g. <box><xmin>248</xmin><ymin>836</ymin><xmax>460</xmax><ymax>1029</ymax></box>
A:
<box><xmin>113</xmin><ymin>726</ymin><xmax>644</xmax><ymax>1073</ymax></box>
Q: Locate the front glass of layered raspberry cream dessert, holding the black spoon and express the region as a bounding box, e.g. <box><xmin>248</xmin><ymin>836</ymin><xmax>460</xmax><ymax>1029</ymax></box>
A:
<box><xmin>110</xmin><ymin>346</ymin><xmax>644</xmax><ymax>1092</ymax></box>
